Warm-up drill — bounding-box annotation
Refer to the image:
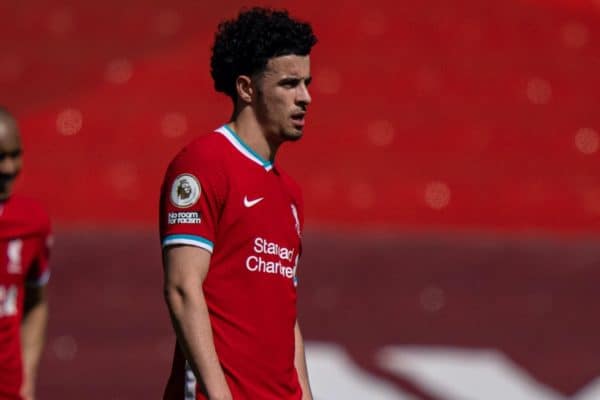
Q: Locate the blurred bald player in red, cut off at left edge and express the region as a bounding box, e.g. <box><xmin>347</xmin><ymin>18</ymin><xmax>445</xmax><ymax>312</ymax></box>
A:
<box><xmin>0</xmin><ymin>107</ymin><xmax>50</xmax><ymax>400</ymax></box>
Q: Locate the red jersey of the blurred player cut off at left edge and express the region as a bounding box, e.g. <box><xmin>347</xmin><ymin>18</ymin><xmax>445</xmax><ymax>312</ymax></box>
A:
<box><xmin>0</xmin><ymin>195</ymin><xmax>50</xmax><ymax>399</ymax></box>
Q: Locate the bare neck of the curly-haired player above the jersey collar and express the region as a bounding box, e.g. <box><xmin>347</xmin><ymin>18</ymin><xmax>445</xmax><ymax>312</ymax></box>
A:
<box><xmin>229</xmin><ymin>107</ymin><xmax>281</xmax><ymax>162</ymax></box>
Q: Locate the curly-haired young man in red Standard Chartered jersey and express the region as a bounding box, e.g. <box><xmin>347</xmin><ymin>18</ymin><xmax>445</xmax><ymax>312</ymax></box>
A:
<box><xmin>160</xmin><ymin>8</ymin><xmax>317</xmax><ymax>400</ymax></box>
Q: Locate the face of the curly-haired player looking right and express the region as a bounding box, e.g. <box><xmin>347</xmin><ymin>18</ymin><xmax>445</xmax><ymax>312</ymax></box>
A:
<box><xmin>255</xmin><ymin>55</ymin><xmax>311</xmax><ymax>143</ymax></box>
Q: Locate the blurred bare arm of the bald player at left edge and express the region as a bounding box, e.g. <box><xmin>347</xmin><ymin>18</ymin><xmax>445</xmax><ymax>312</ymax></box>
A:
<box><xmin>21</xmin><ymin>286</ymin><xmax>48</xmax><ymax>400</ymax></box>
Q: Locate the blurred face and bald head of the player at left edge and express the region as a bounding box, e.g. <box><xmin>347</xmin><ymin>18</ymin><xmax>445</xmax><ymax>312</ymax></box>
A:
<box><xmin>0</xmin><ymin>116</ymin><xmax>22</xmax><ymax>200</ymax></box>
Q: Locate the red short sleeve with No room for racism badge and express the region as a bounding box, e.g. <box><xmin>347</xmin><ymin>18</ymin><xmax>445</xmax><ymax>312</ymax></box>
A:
<box><xmin>159</xmin><ymin>148</ymin><xmax>224</xmax><ymax>253</ymax></box>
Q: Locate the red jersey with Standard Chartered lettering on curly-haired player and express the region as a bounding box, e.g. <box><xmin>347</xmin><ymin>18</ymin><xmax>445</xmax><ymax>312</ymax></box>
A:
<box><xmin>160</xmin><ymin>126</ymin><xmax>303</xmax><ymax>400</ymax></box>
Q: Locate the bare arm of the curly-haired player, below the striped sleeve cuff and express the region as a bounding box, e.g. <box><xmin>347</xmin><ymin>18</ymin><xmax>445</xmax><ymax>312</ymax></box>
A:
<box><xmin>163</xmin><ymin>246</ymin><xmax>232</xmax><ymax>400</ymax></box>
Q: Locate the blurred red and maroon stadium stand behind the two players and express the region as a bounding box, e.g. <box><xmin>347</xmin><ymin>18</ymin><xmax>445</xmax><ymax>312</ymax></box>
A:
<box><xmin>0</xmin><ymin>0</ymin><xmax>600</xmax><ymax>400</ymax></box>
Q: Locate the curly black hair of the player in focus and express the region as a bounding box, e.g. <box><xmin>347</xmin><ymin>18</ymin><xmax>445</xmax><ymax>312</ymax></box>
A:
<box><xmin>210</xmin><ymin>7</ymin><xmax>317</xmax><ymax>101</ymax></box>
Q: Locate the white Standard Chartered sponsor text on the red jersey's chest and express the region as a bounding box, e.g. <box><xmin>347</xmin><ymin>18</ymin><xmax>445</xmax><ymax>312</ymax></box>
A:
<box><xmin>246</xmin><ymin>237</ymin><xmax>298</xmax><ymax>279</ymax></box>
